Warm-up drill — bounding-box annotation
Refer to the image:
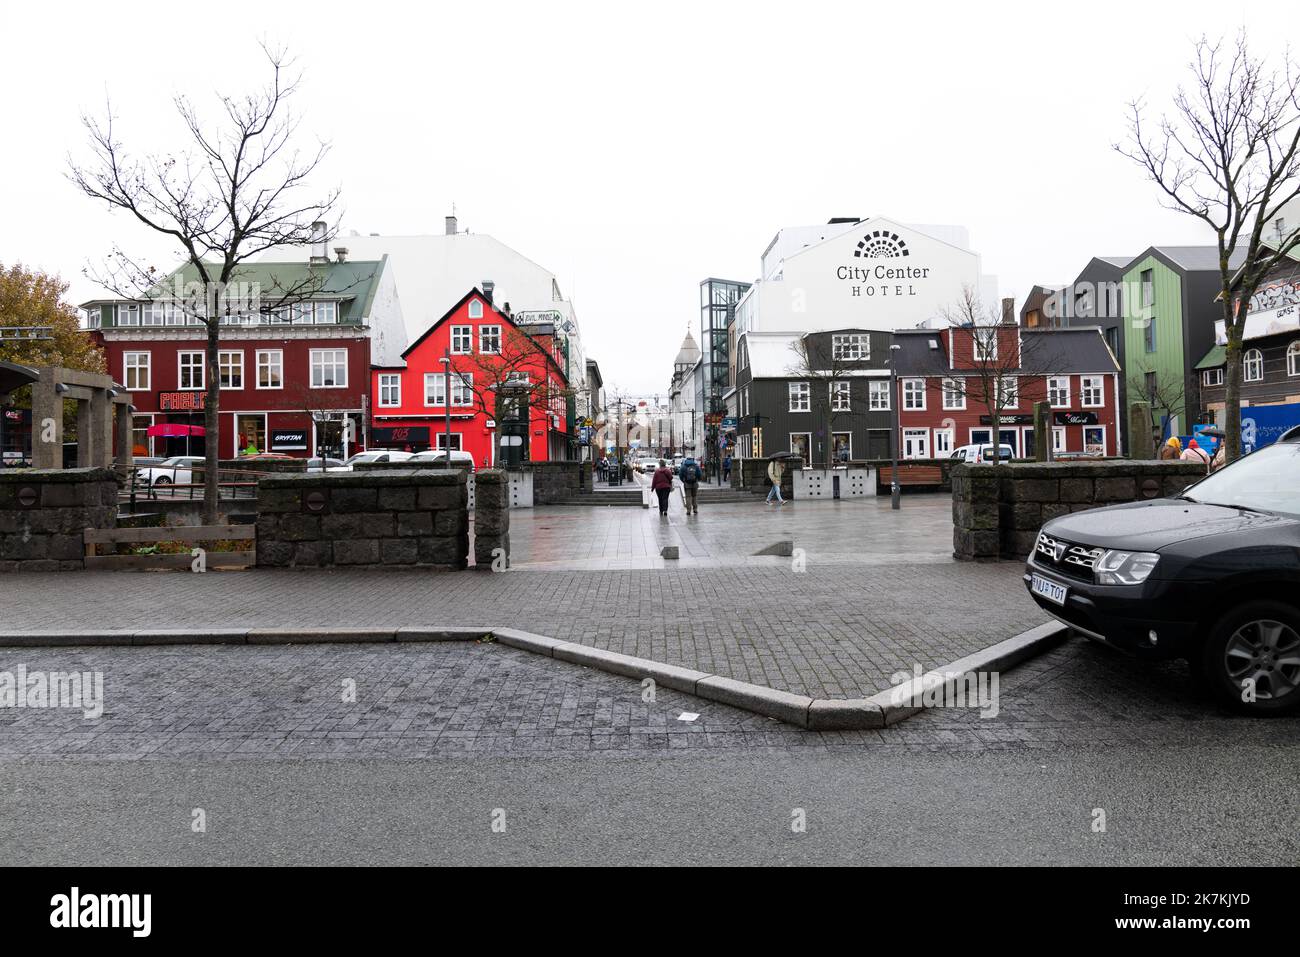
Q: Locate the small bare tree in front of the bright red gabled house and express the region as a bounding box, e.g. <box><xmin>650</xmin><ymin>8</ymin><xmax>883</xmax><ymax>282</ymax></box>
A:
<box><xmin>447</xmin><ymin>322</ymin><xmax>576</xmax><ymax>463</ymax></box>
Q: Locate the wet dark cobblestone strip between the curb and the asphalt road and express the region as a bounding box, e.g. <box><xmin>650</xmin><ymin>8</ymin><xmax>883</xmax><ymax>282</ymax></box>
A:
<box><xmin>0</xmin><ymin>640</ymin><xmax>1300</xmax><ymax>761</ymax></box>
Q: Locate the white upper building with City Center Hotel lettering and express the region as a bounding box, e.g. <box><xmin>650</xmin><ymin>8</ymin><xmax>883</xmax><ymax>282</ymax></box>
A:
<box><xmin>736</xmin><ymin>216</ymin><xmax>997</xmax><ymax>337</ymax></box>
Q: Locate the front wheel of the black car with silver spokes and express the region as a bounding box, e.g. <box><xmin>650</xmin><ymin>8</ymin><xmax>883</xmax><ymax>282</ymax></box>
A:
<box><xmin>1200</xmin><ymin>601</ymin><xmax>1300</xmax><ymax>716</ymax></box>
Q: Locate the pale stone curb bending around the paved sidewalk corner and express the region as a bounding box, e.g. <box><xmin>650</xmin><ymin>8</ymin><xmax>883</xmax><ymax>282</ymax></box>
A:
<box><xmin>0</xmin><ymin>622</ymin><xmax>1070</xmax><ymax>731</ymax></box>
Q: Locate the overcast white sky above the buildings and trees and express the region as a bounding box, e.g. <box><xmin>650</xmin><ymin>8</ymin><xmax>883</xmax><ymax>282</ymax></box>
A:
<box><xmin>0</xmin><ymin>0</ymin><xmax>1295</xmax><ymax>393</ymax></box>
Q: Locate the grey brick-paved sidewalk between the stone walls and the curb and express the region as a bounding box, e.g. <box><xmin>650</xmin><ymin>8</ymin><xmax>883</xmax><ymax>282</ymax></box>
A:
<box><xmin>0</xmin><ymin>559</ymin><xmax>1045</xmax><ymax>698</ymax></box>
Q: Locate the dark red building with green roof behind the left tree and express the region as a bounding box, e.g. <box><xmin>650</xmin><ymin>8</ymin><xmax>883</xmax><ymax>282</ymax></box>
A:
<box><xmin>82</xmin><ymin>256</ymin><xmax>403</xmax><ymax>459</ymax></box>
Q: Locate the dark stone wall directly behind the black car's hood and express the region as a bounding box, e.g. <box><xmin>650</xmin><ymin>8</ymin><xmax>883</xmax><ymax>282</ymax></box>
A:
<box><xmin>952</xmin><ymin>459</ymin><xmax>1205</xmax><ymax>562</ymax></box>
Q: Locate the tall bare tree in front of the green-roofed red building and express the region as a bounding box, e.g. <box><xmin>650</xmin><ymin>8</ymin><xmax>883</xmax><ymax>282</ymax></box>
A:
<box><xmin>69</xmin><ymin>47</ymin><xmax>338</xmax><ymax>524</ymax></box>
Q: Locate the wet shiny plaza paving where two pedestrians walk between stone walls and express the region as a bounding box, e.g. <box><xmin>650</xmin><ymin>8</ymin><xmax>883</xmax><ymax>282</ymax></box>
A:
<box><xmin>510</xmin><ymin>492</ymin><xmax>953</xmax><ymax>570</ymax></box>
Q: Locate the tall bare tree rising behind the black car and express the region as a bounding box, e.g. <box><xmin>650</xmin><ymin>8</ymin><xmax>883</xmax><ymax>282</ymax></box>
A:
<box><xmin>1114</xmin><ymin>31</ymin><xmax>1300</xmax><ymax>462</ymax></box>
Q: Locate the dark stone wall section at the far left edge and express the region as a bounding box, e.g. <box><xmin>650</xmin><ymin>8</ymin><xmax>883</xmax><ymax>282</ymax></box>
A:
<box><xmin>0</xmin><ymin>468</ymin><xmax>121</xmax><ymax>572</ymax></box>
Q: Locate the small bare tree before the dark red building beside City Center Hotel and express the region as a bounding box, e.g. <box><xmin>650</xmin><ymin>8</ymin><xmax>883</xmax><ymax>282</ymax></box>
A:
<box><xmin>941</xmin><ymin>286</ymin><xmax>1065</xmax><ymax>464</ymax></box>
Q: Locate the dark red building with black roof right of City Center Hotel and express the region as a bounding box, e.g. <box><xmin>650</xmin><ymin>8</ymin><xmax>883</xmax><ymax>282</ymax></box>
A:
<box><xmin>894</xmin><ymin>325</ymin><xmax>1122</xmax><ymax>459</ymax></box>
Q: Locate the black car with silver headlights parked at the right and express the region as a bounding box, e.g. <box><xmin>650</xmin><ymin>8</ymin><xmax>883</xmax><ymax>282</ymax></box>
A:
<box><xmin>1024</xmin><ymin>429</ymin><xmax>1300</xmax><ymax>715</ymax></box>
